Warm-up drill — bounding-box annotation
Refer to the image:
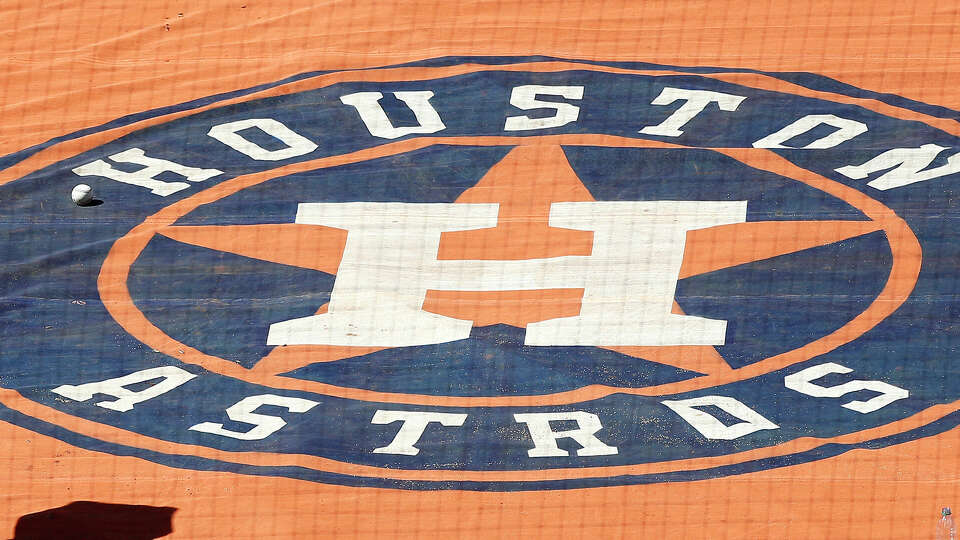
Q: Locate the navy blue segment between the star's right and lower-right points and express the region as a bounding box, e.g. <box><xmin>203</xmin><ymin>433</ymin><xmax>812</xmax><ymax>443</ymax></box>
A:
<box><xmin>677</xmin><ymin>232</ymin><xmax>892</xmax><ymax>368</ymax></box>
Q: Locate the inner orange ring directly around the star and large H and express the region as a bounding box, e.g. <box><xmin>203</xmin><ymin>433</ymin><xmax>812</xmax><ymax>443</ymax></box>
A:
<box><xmin>98</xmin><ymin>134</ymin><xmax>921</xmax><ymax>407</ymax></box>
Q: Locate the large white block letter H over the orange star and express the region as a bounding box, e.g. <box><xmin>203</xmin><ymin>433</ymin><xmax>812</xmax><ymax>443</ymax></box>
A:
<box><xmin>267</xmin><ymin>201</ymin><xmax>746</xmax><ymax>347</ymax></box>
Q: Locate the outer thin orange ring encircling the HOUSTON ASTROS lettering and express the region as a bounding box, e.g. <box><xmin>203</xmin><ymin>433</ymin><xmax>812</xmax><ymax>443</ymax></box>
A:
<box><xmin>0</xmin><ymin>62</ymin><xmax>944</xmax><ymax>481</ymax></box>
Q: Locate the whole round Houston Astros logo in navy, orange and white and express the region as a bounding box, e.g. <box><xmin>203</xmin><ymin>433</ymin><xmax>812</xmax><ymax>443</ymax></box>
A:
<box><xmin>0</xmin><ymin>59</ymin><xmax>960</xmax><ymax>490</ymax></box>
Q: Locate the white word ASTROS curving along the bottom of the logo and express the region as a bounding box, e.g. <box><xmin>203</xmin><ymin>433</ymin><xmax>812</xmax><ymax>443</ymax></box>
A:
<box><xmin>53</xmin><ymin>363</ymin><xmax>910</xmax><ymax>458</ymax></box>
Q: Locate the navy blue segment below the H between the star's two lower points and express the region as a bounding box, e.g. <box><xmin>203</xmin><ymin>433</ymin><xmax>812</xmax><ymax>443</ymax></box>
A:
<box><xmin>288</xmin><ymin>325</ymin><xmax>697</xmax><ymax>396</ymax></box>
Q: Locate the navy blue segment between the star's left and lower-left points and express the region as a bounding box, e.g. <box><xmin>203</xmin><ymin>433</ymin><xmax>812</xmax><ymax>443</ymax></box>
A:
<box><xmin>129</xmin><ymin>237</ymin><xmax>333</xmax><ymax>368</ymax></box>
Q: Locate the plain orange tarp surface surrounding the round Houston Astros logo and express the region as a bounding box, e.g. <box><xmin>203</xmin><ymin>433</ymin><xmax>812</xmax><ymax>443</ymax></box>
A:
<box><xmin>0</xmin><ymin>0</ymin><xmax>960</xmax><ymax>539</ymax></box>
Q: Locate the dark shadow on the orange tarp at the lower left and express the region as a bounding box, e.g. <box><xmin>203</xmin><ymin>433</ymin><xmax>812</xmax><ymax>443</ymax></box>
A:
<box><xmin>13</xmin><ymin>501</ymin><xmax>177</xmax><ymax>540</ymax></box>
